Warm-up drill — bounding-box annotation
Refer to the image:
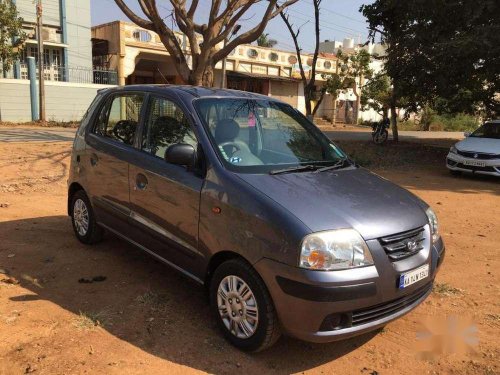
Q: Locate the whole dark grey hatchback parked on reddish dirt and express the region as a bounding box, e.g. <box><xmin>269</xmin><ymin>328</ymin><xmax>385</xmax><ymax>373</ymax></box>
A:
<box><xmin>68</xmin><ymin>86</ymin><xmax>444</xmax><ymax>351</ymax></box>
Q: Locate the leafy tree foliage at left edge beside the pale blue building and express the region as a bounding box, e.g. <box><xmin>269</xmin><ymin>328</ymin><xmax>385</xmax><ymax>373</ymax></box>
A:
<box><xmin>0</xmin><ymin>0</ymin><xmax>26</xmax><ymax>72</ymax></box>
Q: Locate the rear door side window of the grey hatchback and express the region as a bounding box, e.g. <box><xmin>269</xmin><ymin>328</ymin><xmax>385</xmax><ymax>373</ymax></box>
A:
<box><xmin>94</xmin><ymin>94</ymin><xmax>144</xmax><ymax>146</ymax></box>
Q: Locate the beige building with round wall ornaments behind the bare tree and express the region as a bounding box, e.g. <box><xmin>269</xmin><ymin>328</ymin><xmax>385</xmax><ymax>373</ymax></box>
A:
<box><xmin>92</xmin><ymin>21</ymin><xmax>337</xmax><ymax>117</ymax></box>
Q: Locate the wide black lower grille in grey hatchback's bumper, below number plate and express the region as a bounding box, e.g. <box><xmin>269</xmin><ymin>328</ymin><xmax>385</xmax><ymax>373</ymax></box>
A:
<box><xmin>352</xmin><ymin>283</ymin><xmax>432</xmax><ymax>327</ymax></box>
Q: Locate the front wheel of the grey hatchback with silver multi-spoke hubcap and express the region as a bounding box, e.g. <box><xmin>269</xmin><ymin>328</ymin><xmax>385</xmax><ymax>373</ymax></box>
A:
<box><xmin>210</xmin><ymin>259</ymin><xmax>281</xmax><ymax>352</ymax></box>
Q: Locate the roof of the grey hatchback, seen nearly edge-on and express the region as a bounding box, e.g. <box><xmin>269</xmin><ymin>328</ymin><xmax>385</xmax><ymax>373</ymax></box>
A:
<box><xmin>100</xmin><ymin>85</ymin><xmax>272</xmax><ymax>100</ymax></box>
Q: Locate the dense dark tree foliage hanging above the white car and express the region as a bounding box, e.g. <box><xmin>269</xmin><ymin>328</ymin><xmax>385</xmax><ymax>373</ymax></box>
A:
<box><xmin>360</xmin><ymin>0</ymin><xmax>500</xmax><ymax>116</ymax></box>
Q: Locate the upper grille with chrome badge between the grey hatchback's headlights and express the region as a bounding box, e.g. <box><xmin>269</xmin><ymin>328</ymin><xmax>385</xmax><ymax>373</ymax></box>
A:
<box><xmin>379</xmin><ymin>227</ymin><xmax>425</xmax><ymax>262</ymax></box>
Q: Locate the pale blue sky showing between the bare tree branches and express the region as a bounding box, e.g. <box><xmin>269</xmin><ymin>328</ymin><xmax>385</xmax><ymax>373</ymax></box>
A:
<box><xmin>91</xmin><ymin>0</ymin><xmax>372</xmax><ymax>52</ymax></box>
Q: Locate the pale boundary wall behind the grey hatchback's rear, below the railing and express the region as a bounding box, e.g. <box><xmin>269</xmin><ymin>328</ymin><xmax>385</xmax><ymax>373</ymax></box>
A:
<box><xmin>0</xmin><ymin>79</ymin><xmax>112</xmax><ymax>122</ymax></box>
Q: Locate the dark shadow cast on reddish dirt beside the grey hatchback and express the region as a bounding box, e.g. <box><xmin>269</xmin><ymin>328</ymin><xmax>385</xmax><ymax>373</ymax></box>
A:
<box><xmin>0</xmin><ymin>216</ymin><xmax>376</xmax><ymax>374</ymax></box>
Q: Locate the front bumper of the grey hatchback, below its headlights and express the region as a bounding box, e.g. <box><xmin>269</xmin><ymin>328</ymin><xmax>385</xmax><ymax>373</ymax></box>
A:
<box><xmin>255</xmin><ymin>236</ymin><xmax>444</xmax><ymax>343</ymax></box>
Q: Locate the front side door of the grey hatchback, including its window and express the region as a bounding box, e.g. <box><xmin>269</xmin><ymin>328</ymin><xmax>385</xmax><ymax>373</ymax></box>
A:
<box><xmin>129</xmin><ymin>95</ymin><xmax>203</xmax><ymax>275</ymax></box>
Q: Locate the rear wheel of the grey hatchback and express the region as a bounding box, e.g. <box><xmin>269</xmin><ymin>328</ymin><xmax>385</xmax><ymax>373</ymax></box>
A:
<box><xmin>71</xmin><ymin>190</ymin><xmax>104</xmax><ymax>245</ymax></box>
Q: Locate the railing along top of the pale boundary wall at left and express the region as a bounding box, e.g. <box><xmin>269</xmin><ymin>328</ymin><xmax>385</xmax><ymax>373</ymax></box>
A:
<box><xmin>3</xmin><ymin>63</ymin><xmax>118</xmax><ymax>85</ymax></box>
